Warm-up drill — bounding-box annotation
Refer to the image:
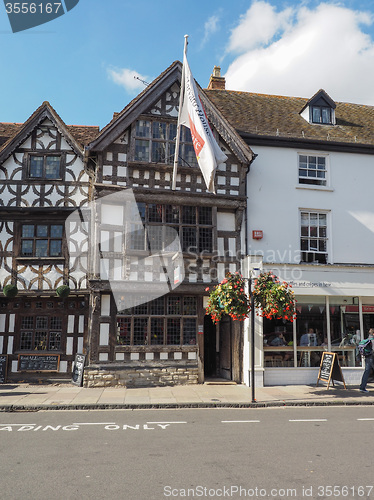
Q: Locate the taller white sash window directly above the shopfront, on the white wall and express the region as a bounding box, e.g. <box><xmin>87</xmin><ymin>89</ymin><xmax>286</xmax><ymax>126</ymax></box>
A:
<box><xmin>299</xmin><ymin>209</ymin><xmax>330</xmax><ymax>264</ymax></box>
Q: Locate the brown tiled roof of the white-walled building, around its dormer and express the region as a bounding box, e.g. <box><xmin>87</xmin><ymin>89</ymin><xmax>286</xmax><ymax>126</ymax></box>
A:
<box><xmin>205</xmin><ymin>90</ymin><xmax>374</xmax><ymax>146</ymax></box>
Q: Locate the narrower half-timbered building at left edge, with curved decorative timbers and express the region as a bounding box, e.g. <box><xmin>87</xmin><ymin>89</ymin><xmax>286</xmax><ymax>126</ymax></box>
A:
<box><xmin>0</xmin><ymin>102</ymin><xmax>99</xmax><ymax>379</ymax></box>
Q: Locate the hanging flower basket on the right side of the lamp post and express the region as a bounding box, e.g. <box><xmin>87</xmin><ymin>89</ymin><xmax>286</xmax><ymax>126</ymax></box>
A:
<box><xmin>253</xmin><ymin>272</ymin><xmax>296</xmax><ymax>322</ymax></box>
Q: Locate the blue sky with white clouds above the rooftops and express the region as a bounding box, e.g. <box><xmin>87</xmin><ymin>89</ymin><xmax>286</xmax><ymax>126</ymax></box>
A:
<box><xmin>0</xmin><ymin>0</ymin><xmax>374</xmax><ymax>127</ymax></box>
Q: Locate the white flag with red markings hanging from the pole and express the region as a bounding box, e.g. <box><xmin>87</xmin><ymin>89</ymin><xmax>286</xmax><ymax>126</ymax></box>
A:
<box><xmin>179</xmin><ymin>54</ymin><xmax>227</xmax><ymax>193</ymax></box>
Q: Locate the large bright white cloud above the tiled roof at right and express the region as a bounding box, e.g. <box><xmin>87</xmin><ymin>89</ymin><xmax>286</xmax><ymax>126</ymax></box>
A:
<box><xmin>225</xmin><ymin>1</ymin><xmax>374</xmax><ymax>105</ymax></box>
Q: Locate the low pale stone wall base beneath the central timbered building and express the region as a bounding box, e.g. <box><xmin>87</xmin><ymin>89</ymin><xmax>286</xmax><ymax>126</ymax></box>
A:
<box><xmin>83</xmin><ymin>364</ymin><xmax>198</xmax><ymax>387</ymax></box>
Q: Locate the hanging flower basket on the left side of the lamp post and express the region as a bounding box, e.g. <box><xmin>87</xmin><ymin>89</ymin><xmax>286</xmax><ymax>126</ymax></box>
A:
<box><xmin>205</xmin><ymin>273</ymin><xmax>251</xmax><ymax>323</ymax></box>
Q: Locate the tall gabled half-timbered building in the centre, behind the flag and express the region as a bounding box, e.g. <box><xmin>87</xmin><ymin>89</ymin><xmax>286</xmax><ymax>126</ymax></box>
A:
<box><xmin>86</xmin><ymin>62</ymin><xmax>252</xmax><ymax>385</ymax></box>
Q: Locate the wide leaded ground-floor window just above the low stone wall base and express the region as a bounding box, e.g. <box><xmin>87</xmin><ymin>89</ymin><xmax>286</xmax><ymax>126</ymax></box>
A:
<box><xmin>117</xmin><ymin>295</ymin><xmax>197</xmax><ymax>345</ymax></box>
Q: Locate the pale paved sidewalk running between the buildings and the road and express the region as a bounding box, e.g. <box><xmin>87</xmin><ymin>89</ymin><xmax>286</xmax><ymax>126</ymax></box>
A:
<box><xmin>0</xmin><ymin>381</ymin><xmax>374</xmax><ymax>412</ymax></box>
